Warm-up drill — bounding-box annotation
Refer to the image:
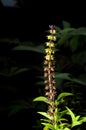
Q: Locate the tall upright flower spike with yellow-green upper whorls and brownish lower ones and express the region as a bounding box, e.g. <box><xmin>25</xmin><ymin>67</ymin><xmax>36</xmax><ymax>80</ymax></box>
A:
<box><xmin>44</xmin><ymin>25</ymin><xmax>56</xmax><ymax>125</ymax></box>
